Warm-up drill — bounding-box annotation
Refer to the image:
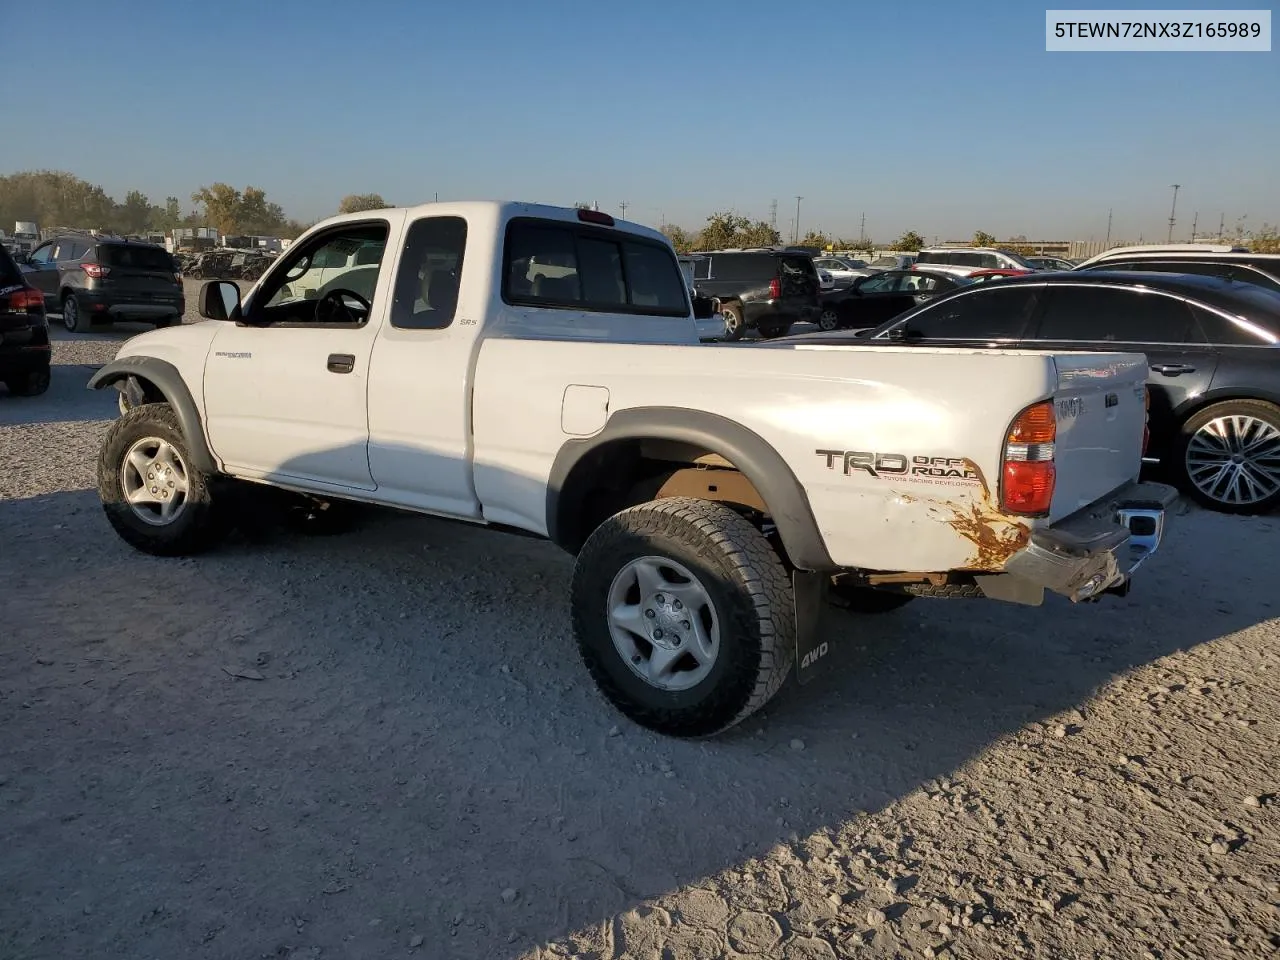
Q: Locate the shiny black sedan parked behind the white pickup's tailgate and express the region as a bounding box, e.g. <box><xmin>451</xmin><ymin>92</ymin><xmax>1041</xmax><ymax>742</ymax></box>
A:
<box><xmin>793</xmin><ymin>267</ymin><xmax>1280</xmax><ymax>513</ymax></box>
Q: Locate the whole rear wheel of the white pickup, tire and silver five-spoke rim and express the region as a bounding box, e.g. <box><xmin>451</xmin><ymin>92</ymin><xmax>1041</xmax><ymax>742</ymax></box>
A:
<box><xmin>572</xmin><ymin>497</ymin><xmax>796</xmax><ymax>737</ymax></box>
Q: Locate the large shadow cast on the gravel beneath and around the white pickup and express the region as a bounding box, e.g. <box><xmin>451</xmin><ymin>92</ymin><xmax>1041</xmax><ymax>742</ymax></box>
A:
<box><xmin>0</xmin><ymin>445</ymin><xmax>1280</xmax><ymax>957</ymax></box>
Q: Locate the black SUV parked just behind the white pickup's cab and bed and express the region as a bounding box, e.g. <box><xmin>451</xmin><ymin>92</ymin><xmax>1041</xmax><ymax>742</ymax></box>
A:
<box><xmin>694</xmin><ymin>250</ymin><xmax>822</xmax><ymax>340</ymax></box>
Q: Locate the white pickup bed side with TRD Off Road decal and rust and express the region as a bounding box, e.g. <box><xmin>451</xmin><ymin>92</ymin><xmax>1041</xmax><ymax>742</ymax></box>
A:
<box><xmin>474</xmin><ymin>339</ymin><xmax>1137</xmax><ymax>571</ymax></box>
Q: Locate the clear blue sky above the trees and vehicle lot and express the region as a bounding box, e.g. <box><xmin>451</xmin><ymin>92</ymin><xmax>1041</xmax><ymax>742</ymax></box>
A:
<box><xmin>0</xmin><ymin>0</ymin><xmax>1280</xmax><ymax>241</ymax></box>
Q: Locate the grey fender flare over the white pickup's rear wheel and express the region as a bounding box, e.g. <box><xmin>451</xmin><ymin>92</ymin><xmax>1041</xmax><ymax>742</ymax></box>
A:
<box><xmin>547</xmin><ymin>407</ymin><xmax>836</xmax><ymax>571</ymax></box>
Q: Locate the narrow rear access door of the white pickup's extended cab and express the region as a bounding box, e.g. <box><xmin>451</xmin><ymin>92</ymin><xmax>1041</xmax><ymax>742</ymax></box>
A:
<box><xmin>369</xmin><ymin>216</ymin><xmax>492</xmax><ymax>520</ymax></box>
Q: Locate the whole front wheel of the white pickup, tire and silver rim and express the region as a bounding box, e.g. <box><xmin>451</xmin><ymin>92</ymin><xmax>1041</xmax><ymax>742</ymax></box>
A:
<box><xmin>97</xmin><ymin>403</ymin><xmax>223</xmax><ymax>557</ymax></box>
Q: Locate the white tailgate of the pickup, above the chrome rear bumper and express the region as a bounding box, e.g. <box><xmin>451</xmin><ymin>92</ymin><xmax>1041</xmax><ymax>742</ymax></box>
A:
<box><xmin>1050</xmin><ymin>353</ymin><xmax>1148</xmax><ymax>522</ymax></box>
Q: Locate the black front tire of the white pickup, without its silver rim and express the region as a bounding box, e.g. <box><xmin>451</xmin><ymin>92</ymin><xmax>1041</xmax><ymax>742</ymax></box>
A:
<box><xmin>97</xmin><ymin>403</ymin><xmax>225</xmax><ymax>557</ymax></box>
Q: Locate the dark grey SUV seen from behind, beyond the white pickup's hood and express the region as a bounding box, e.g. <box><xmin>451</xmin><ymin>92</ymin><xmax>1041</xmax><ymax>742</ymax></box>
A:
<box><xmin>22</xmin><ymin>234</ymin><xmax>187</xmax><ymax>333</ymax></box>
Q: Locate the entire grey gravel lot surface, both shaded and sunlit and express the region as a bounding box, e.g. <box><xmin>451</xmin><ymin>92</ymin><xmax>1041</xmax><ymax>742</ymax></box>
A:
<box><xmin>0</xmin><ymin>284</ymin><xmax>1280</xmax><ymax>960</ymax></box>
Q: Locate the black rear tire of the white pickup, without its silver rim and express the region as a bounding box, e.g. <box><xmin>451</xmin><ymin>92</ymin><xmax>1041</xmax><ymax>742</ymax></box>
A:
<box><xmin>571</xmin><ymin>497</ymin><xmax>796</xmax><ymax>737</ymax></box>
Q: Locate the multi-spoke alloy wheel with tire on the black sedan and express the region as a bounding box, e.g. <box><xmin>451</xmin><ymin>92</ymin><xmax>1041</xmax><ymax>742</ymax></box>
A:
<box><xmin>1174</xmin><ymin>401</ymin><xmax>1280</xmax><ymax>513</ymax></box>
